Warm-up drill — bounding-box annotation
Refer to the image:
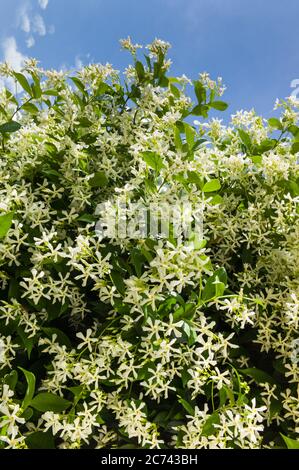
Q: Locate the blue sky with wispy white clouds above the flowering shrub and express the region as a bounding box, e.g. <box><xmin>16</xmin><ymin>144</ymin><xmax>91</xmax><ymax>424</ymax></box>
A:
<box><xmin>0</xmin><ymin>0</ymin><xmax>299</xmax><ymax>117</ymax></box>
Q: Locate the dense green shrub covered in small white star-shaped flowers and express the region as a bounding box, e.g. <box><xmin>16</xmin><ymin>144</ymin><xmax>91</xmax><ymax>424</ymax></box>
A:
<box><xmin>0</xmin><ymin>39</ymin><xmax>299</xmax><ymax>448</ymax></box>
